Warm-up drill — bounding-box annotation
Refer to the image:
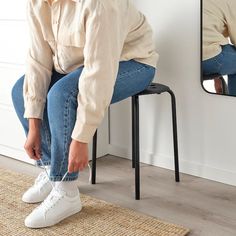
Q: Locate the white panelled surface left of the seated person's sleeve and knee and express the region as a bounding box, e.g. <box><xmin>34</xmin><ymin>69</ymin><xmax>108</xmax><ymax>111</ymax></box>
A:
<box><xmin>0</xmin><ymin>0</ymin><xmax>33</xmax><ymax>163</ymax></box>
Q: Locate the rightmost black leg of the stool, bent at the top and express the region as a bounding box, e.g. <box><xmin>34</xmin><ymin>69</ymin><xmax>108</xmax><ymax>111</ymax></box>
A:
<box><xmin>168</xmin><ymin>90</ymin><xmax>180</xmax><ymax>182</ymax></box>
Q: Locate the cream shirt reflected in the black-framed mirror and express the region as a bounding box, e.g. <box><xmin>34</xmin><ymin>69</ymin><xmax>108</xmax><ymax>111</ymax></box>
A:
<box><xmin>202</xmin><ymin>0</ymin><xmax>236</xmax><ymax>60</ymax></box>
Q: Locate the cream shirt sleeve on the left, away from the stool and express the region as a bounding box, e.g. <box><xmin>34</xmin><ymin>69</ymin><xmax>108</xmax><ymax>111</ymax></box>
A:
<box><xmin>23</xmin><ymin>1</ymin><xmax>53</xmax><ymax>120</ymax></box>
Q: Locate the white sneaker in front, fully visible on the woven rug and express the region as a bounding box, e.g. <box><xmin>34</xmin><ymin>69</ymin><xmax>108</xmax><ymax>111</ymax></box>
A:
<box><xmin>25</xmin><ymin>184</ymin><xmax>82</xmax><ymax>228</ymax></box>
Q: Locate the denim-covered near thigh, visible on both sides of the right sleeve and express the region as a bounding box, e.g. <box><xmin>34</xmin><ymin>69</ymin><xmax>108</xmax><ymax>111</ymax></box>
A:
<box><xmin>48</xmin><ymin>60</ymin><xmax>156</xmax><ymax>106</ymax></box>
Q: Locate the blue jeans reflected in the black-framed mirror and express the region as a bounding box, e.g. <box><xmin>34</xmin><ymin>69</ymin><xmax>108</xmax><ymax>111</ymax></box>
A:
<box><xmin>202</xmin><ymin>44</ymin><xmax>236</xmax><ymax>96</ymax></box>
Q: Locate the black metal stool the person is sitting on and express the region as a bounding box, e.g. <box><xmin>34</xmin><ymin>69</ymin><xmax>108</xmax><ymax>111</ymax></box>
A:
<box><xmin>92</xmin><ymin>83</ymin><xmax>180</xmax><ymax>200</ymax></box>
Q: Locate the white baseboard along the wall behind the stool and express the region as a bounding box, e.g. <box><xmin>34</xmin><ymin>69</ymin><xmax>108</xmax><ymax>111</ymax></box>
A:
<box><xmin>108</xmin><ymin>144</ymin><xmax>236</xmax><ymax>186</ymax></box>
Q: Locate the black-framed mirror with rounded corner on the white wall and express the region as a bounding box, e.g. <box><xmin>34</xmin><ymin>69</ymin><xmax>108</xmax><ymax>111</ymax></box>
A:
<box><xmin>201</xmin><ymin>0</ymin><xmax>236</xmax><ymax>96</ymax></box>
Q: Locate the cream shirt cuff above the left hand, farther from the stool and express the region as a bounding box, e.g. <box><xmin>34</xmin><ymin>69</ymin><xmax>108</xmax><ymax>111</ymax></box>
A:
<box><xmin>24</xmin><ymin>100</ymin><xmax>45</xmax><ymax>120</ymax></box>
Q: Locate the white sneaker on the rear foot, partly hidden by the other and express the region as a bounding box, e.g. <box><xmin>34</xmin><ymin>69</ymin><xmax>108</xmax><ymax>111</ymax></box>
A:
<box><xmin>22</xmin><ymin>171</ymin><xmax>52</xmax><ymax>203</ymax></box>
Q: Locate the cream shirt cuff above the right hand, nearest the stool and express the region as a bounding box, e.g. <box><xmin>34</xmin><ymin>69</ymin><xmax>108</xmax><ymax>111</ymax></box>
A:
<box><xmin>71</xmin><ymin>120</ymin><xmax>97</xmax><ymax>143</ymax></box>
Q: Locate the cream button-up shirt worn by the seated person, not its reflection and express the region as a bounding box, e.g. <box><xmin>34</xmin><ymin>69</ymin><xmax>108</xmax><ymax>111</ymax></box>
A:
<box><xmin>23</xmin><ymin>0</ymin><xmax>158</xmax><ymax>143</ymax></box>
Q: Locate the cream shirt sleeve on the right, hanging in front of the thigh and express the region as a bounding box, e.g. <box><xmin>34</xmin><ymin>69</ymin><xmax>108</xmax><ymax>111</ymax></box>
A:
<box><xmin>71</xmin><ymin>0</ymin><xmax>122</xmax><ymax>143</ymax></box>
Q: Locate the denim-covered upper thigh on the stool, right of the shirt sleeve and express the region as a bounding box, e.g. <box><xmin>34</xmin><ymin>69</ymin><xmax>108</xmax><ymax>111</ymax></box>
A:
<box><xmin>111</xmin><ymin>60</ymin><xmax>156</xmax><ymax>104</ymax></box>
